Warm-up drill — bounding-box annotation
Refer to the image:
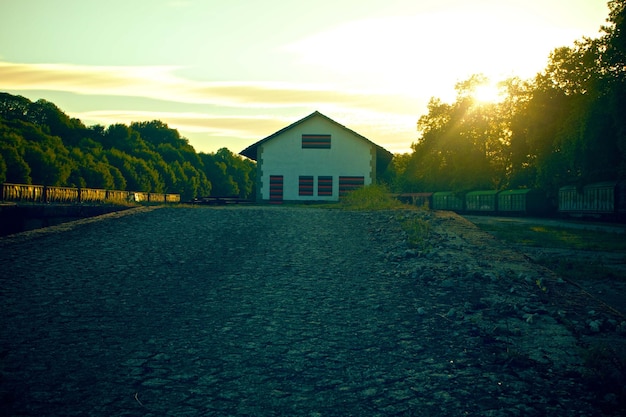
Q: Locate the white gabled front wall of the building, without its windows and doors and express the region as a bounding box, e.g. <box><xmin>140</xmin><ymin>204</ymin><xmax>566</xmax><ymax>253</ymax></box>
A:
<box><xmin>257</xmin><ymin>117</ymin><xmax>375</xmax><ymax>201</ymax></box>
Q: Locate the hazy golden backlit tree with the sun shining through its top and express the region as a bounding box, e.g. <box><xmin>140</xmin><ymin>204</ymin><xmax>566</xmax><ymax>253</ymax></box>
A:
<box><xmin>405</xmin><ymin>75</ymin><xmax>508</xmax><ymax>191</ymax></box>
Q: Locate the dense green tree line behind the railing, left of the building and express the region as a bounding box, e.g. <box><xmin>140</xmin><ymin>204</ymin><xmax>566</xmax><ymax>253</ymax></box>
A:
<box><xmin>0</xmin><ymin>93</ymin><xmax>256</xmax><ymax>201</ymax></box>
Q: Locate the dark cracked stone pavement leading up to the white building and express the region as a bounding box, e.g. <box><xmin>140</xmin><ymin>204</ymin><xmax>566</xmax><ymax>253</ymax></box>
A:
<box><xmin>0</xmin><ymin>207</ymin><xmax>616</xmax><ymax>416</ymax></box>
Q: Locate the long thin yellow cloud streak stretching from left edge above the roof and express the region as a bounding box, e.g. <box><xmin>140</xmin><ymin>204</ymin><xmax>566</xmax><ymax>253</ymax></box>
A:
<box><xmin>0</xmin><ymin>62</ymin><xmax>415</xmax><ymax>112</ymax></box>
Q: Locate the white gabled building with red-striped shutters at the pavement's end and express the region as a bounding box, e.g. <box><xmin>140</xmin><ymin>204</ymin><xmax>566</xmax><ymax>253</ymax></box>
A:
<box><xmin>240</xmin><ymin>111</ymin><xmax>393</xmax><ymax>203</ymax></box>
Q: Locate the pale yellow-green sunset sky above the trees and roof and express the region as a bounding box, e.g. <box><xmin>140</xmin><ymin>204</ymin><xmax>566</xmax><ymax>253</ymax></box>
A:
<box><xmin>0</xmin><ymin>0</ymin><xmax>608</xmax><ymax>153</ymax></box>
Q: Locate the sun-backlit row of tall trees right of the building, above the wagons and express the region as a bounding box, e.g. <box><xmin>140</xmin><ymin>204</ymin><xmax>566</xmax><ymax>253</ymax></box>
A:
<box><xmin>386</xmin><ymin>0</ymin><xmax>626</xmax><ymax>195</ymax></box>
